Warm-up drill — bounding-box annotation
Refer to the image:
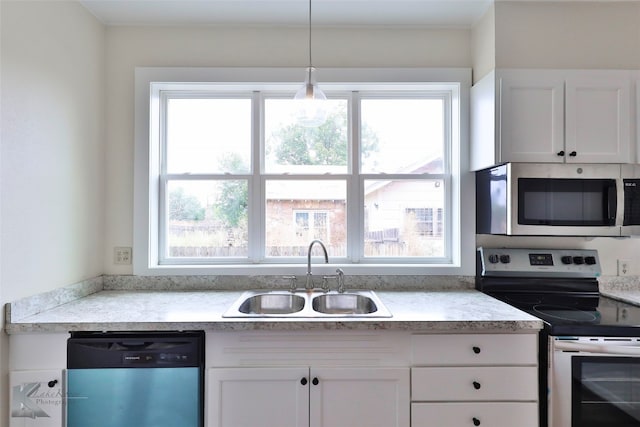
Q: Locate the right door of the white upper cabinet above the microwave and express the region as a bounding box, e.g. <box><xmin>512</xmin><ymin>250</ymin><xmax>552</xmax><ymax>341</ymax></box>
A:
<box><xmin>566</xmin><ymin>75</ymin><xmax>633</xmax><ymax>163</ymax></box>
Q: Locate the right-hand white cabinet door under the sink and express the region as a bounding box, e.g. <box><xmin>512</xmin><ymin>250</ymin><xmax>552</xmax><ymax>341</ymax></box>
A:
<box><xmin>309</xmin><ymin>368</ymin><xmax>410</xmax><ymax>427</ymax></box>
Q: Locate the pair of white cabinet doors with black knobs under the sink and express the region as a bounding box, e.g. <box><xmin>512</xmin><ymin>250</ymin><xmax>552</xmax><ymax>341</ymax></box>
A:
<box><xmin>207</xmin><ymin>367</ymin><xmax>409</xmax><ymax>427</ymax></box>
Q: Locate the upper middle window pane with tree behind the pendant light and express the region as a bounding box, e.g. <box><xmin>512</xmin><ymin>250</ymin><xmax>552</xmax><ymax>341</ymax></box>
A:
<box><xmin>265</xmin><ymin>99</ymin><xmax>348</xmax><ymax>174</ymax></box>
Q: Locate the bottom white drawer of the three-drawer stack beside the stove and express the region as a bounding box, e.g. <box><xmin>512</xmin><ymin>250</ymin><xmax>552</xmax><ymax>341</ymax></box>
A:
<box><xmin>411</xmin><ymin>402</ymin><xmax>538</xmax><ymax>427</ymax></box>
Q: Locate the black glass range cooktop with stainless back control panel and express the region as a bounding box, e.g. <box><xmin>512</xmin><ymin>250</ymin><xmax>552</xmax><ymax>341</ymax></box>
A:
<box><xmin>476</xmin><ymin>248</ymin><xmax>640</xmax><ymax>336</ymax></box>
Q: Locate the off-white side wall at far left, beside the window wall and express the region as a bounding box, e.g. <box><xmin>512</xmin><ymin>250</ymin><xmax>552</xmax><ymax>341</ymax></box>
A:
<box><xmin>0</xmin><ymin>0</ymin><xmax>105</xmax><ymax>426</ymax></box>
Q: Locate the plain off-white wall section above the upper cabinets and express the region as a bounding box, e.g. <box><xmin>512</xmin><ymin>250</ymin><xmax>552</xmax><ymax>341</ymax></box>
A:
<box><xmin>495</xmin><ymin>1</ymin><xmax>640</xmax><ymax>69</ymax></box>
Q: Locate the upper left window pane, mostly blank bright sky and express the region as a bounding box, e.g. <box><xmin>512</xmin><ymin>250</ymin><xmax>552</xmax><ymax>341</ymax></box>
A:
<box><xmin>167</xmin><ymin>98</ymin><xmax>251</xmax><ymax>173</ymax></box>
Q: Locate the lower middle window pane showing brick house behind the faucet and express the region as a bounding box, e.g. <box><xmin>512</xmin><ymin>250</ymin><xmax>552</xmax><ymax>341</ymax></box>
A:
<box><xmin>266</xmin><ymin>180</ymin><xmax>347</xmax><ymax>257</ymax></box>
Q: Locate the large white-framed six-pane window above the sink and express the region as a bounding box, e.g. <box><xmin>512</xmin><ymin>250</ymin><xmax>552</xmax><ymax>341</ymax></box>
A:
<box><xmin>134</xmin><ymin>69</ymin><xmax>476</xmax><ymax>274</ymax></box>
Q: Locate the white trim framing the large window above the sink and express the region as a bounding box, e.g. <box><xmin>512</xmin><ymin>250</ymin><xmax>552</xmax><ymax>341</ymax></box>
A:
<box><xmin>133</xmin><ymin>67</ymin><xmax>475</xmax><ymax>276</ymax></box>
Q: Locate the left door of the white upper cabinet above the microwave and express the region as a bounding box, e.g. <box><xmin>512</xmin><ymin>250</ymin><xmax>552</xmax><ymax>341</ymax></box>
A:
<box><xmin>499</xmin><ymin>72</ymin><xmax>564</xmax><ymax>163</ymax></box>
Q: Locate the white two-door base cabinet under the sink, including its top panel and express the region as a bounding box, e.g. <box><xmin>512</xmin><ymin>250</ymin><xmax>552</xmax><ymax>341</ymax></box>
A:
<box><xmin>207</xmin><ymin>330</ymin><xmax>410</xmax><ymax>427</ymax></box>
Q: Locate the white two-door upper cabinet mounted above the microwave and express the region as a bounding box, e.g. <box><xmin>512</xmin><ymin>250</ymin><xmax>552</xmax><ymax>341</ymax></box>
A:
<box><xmin>471</xmin><ymin>70</ymin><xmax>635</xmax><ymax>170</ymax></box>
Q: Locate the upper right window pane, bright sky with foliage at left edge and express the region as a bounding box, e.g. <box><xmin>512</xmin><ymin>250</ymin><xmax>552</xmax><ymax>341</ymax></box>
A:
<box><xmin>361</xmin><ymin>99</ymin><xmax>444</xmax><ymax>173</ymax></box>
